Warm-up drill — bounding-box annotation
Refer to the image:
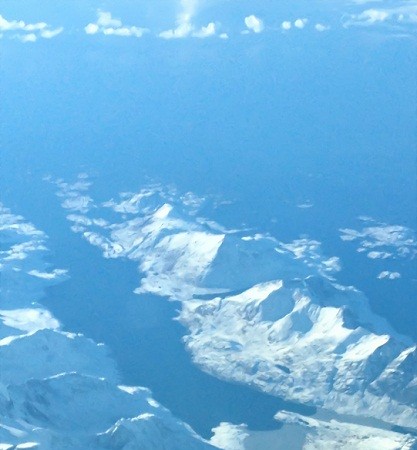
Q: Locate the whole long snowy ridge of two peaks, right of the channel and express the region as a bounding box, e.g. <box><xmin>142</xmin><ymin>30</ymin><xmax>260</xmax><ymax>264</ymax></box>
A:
<box><xmin>50</xmin><ymin>177</ymin><xmax>417</xmax><ymax>436</ymax></box>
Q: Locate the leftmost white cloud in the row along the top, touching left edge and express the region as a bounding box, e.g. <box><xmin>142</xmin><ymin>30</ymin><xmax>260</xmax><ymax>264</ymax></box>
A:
<box><xmin>0</xmin><ymin>15</ymin><xmax>64</xmax><ymax>42</ymax></box>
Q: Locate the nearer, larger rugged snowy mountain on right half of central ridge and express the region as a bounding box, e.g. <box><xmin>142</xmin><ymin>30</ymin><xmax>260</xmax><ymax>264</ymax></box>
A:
<box><xmin>181</xmin><ymin>277</ymin><xmax>417</xmax><ymax>427</ymax></box>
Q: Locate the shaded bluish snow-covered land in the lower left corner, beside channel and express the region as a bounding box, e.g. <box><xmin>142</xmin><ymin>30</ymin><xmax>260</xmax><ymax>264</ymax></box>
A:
<box><xmin>0</xmin><ymin>205</ymin><xmax>214</xmax><ymax>450</ymax></box>
